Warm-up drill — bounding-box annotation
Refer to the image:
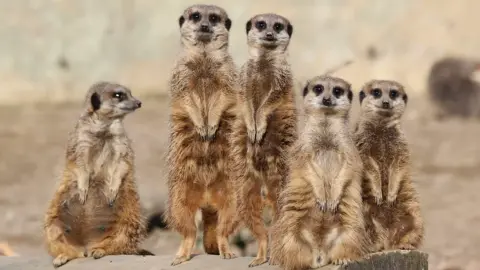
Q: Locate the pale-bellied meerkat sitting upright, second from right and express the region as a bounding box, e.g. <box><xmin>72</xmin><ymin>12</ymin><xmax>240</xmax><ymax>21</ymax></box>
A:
<box><xmin>269</xmin><ymin>76</ymin><xmax>369</xmax><ymax>270</ymax></box>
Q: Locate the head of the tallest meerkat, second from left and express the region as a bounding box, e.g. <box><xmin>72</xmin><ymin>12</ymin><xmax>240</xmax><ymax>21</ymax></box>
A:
<box><xmin>178</xmin><ymin>5</ymin><xmax>232</xmax><ymax>46</ymax></box>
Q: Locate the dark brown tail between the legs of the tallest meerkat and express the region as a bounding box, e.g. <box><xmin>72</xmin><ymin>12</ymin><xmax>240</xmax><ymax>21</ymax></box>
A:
<box><xmin>202</xmin><ymin>209</ymin><xmax>220</xmax><ymax>255</ymax></box>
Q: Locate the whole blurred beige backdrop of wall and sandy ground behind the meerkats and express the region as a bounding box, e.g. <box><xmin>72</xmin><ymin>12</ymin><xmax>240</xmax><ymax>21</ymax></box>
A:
<box><xmin>0</xmin><ymin>0</ymin><xmax>480</xmax><ymax>270</ymax></box>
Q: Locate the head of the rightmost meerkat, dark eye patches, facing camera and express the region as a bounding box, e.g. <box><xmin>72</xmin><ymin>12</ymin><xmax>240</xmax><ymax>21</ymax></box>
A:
<box><xmin>359</xmin><ymin>80</ymin><xmax>408</xmax><ymax>117</ymax></box>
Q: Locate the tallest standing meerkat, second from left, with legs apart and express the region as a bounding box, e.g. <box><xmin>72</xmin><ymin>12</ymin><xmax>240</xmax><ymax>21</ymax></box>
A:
<box><xmin>165</xmin><ymin>5</ymin><xmax>237</xmax><ymax>265</ymax></box>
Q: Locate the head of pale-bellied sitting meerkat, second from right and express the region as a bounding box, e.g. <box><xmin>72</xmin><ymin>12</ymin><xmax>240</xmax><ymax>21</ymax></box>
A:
<box><xmin>303</xmin><ymin>76</ymin><xmax>353</xmax><ymax>115</ymax></box>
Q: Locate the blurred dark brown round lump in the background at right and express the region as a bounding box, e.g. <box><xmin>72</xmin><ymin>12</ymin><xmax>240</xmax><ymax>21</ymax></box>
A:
<box><xmin>427</xmin><ymin>57</ymin><xmax>480</xmax><ymax>119</ymax></box>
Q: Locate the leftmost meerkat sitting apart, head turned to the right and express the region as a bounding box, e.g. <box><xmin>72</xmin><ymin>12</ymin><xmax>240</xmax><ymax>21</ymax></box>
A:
<box><xmin>44</xmin><ymin>82</ymin><xmax>146</xmax><ymax>267</ymax></box>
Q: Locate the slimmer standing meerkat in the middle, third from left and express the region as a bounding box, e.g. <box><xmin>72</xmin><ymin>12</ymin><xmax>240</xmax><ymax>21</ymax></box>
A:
<box><xmin>232</xmin><ymin>14</ymin><xmax>297</xmax><ymax>267</ymax></box>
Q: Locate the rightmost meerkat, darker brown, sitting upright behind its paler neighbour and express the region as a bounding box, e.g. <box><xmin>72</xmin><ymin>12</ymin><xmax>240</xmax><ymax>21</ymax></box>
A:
<box><xmin>354</xmin><ymin>80</ymin><xmax>424</xmax><ymax>251</ymax></box>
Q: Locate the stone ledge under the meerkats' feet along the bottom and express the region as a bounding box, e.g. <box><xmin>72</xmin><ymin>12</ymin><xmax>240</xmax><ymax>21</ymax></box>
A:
<box><xmin>0</xmin><ymin>251</ymin><xmax>428</xmax><ymax>270</ymax></box>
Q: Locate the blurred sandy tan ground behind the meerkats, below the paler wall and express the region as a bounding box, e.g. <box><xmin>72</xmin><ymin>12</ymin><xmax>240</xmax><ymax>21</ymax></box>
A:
<box><xmin>0</xmin><ymin>93</ymin><xmax>480</xmax><ymax>270</ymax></box>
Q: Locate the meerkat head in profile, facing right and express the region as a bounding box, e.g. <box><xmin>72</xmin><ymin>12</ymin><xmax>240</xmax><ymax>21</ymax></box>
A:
<box><xmin>85</xmin><ymin>82</ymin><xmax>142</xmax><ymax>119</ymax></box>
